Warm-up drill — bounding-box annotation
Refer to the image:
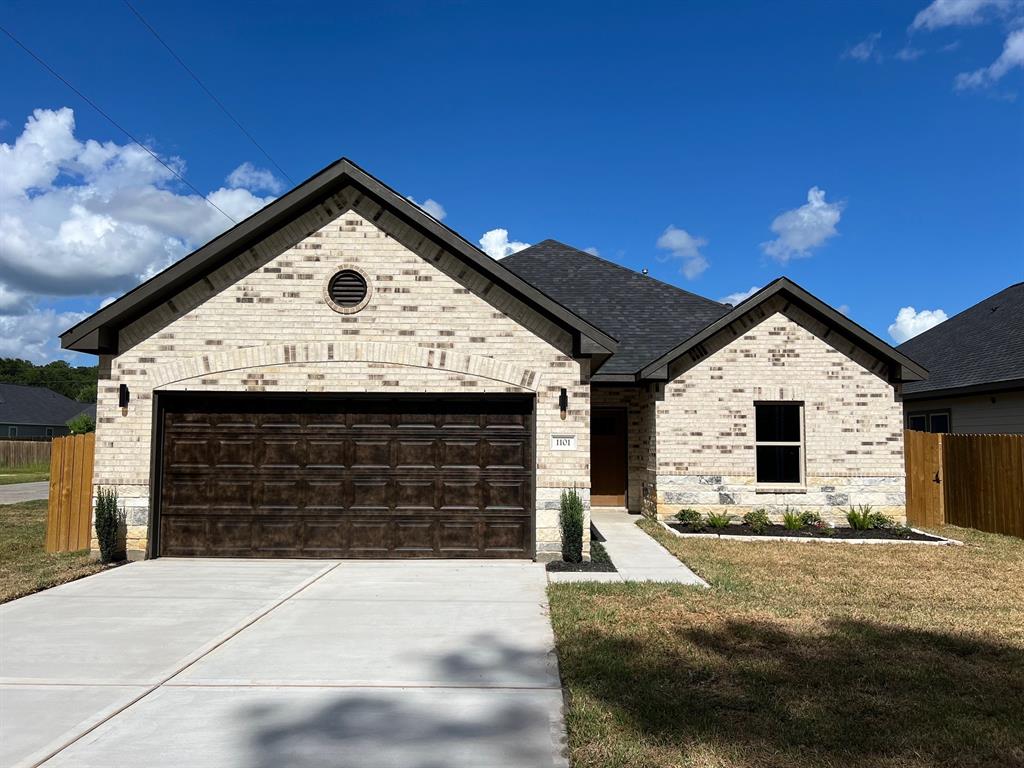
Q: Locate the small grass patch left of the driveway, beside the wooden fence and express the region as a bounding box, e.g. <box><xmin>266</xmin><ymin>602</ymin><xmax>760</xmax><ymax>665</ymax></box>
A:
<box><xmin>0</xmin><ymin>501</ymin><xmax>104</xmax><ymax>603</ymax></box>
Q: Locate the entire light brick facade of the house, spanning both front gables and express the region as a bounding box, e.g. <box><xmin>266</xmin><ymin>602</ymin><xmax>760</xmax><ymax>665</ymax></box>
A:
<box><xmin>93</xmin><ymin>187</ymin><xmax>904</xmax><ymax>559</ymax></box>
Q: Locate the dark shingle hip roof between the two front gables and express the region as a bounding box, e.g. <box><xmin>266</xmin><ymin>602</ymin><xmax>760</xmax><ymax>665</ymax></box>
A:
<box><xmin>502</xmin><ymin>240</ymin><xmax>729</xmax><ymax>374</ymax></box>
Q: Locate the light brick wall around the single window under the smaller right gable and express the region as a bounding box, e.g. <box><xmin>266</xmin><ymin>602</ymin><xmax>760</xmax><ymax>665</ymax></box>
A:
<box><xmin>655</xmin><ymin>301</ymin><xmax>905</xmax><ymax>524</ymax></box>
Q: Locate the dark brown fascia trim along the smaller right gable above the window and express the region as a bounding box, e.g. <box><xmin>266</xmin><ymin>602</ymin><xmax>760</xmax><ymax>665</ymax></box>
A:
<box><xmin>638</xmin><ymin>278</ymin><xmax>928</xmax><ymax>381</ymax></box>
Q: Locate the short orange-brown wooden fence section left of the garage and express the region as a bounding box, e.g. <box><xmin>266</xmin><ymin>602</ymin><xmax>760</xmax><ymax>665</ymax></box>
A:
<box><xmin>46</xmin><ymin>432</ymin><xmax>96</xmax><ymax>552</ymax></box>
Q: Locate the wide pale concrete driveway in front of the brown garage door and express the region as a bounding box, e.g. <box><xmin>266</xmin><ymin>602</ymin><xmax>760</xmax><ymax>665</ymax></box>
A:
<box><xmin>0</xmin><ymin>559</ymin><xmax>567</xmax><ymax>768</ymax></box>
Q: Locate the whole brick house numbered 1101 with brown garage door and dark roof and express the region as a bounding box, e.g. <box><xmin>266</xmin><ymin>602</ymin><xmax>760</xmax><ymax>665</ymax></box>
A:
<box><xmin>61</xmin><ymin>160</ymin><xmax>926</xmax><ymax>559</ymax></box>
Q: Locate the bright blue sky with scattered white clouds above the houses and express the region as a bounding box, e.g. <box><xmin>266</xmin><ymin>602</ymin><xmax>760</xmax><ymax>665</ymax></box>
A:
<box><xmin>0</xmin><ymin>0</ymin><xmax>1024</xmax><ymax>362</ymax></box>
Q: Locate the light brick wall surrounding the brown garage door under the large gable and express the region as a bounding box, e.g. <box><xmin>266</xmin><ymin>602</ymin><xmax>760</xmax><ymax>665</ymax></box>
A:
<box><xmin>94</xmin><ymin>190</ymin><xmax>590</xmax><ymax>559</ymax></box>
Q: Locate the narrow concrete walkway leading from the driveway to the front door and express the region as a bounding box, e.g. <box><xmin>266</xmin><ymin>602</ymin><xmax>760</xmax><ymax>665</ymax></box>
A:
<box><xmin>548</xmin><ymin>507</ymin><xmax>708</xmax><ymax>587</ymax></box>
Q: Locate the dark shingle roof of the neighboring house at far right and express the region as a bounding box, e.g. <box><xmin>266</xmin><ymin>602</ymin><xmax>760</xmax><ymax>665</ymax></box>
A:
<box><xmin>898</xmin><ymin>283</ymin><xmax>1024</xmax><ymax>394</ymax></box>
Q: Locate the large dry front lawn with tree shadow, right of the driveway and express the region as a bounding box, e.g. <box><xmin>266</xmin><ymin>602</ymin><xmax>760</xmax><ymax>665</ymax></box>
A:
<box><xmin>549</xmin><ymin>520</ymin><xmax>1024</xmax><ymax>768</ymax></box>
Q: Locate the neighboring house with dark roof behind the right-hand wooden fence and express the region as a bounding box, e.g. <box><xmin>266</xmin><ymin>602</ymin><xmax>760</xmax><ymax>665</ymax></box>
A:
<box><xmin>899</xmin><ymin>283</ymin><xmax>1024</xmax><ymax>434</ymax></box>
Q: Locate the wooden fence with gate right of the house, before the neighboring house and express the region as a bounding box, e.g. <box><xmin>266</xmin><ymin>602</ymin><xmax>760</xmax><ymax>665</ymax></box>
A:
<box><xmin>903</xmin><ymin>430</ymin><xmax>1024</xmax><ymax>539</ymax></box>
